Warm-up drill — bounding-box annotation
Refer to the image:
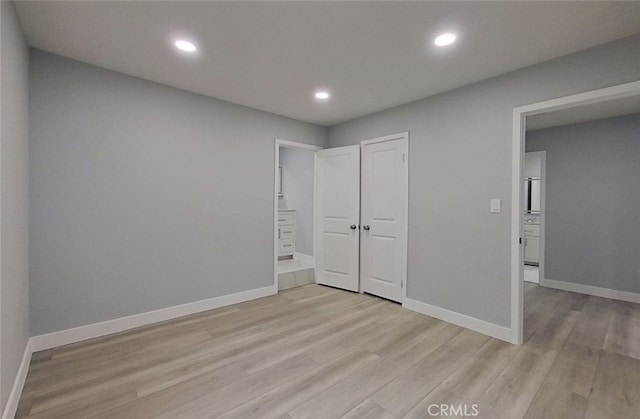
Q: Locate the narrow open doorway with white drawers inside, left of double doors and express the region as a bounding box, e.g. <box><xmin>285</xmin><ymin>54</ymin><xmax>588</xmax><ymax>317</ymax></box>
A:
<box><xmin>273</xmin><ymin>139</ymin><xmax>321</xmax><ymax>291</ymax></box>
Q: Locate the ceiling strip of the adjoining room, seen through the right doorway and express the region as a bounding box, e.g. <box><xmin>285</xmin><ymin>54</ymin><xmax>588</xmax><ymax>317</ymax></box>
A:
<box><xmin>527</xmin><ymin>95</ymin><xmax>640</xmax><ymax>131</ymax></box>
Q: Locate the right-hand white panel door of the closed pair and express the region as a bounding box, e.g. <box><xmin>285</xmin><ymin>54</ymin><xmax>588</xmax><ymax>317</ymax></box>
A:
<box><xmin>360</xmin><ymin>134</ymin><xmax>409</xmax><ymax>302</ymax></box>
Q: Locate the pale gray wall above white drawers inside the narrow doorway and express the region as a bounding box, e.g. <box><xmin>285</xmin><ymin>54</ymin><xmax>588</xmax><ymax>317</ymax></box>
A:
<box><xmin>278</xmin><ymin>147</ymin><xmax>315</xmax><ymax>255</ymax></box>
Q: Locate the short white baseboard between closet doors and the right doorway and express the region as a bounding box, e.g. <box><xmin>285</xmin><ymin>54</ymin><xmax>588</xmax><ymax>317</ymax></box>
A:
<box><xmin>402</xmin><ymin>298</ymin><xmax>513</xmax><ymax>343</ymax></box>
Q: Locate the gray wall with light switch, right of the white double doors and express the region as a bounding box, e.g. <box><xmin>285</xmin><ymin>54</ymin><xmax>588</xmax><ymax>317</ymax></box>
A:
<box><xmin>329</xmin><ymin>35</ymin><xmax>640</xmax><ymax>327</ymax></box>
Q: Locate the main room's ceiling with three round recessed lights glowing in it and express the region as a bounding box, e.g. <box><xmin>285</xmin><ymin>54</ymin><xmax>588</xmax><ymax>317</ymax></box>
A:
<box><xmin>17</xmin><ymin>1</ymin><xmax>640</xmax><ymax>125</ymax></box>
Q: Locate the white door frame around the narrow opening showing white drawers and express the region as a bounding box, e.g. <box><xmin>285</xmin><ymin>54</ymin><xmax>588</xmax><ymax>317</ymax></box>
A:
<box><xmin>273</xmin><ymin>138</ymin><xmax>322</xmax><ymax>293</ymax></box>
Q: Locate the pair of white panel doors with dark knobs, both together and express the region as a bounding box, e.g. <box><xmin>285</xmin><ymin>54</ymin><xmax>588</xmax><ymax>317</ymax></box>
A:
<box><xmin>315</xmin><ymin>133</ymin><xmax>408</xmax><ymax>301</ymax></box>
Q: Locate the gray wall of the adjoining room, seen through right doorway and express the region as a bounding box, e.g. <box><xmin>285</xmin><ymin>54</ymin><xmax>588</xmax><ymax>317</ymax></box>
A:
<box><xmin>526</xmin><ymin>114</ymin><xmax>640</xmax><ymax>292</ymax></box>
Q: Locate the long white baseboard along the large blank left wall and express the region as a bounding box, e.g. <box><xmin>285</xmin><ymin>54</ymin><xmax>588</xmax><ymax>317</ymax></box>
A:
<box><xmin>31</xmin><ymin>285</ymin><xmax>278</xmax><ymax>352</ymax></box>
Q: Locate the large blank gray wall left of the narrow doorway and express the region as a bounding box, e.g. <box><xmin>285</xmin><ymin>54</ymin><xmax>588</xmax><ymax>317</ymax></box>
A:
<box><xmin>30</xmin><ymin>51</ymin><xmax>328</xmax><ymax>335</ymax></box>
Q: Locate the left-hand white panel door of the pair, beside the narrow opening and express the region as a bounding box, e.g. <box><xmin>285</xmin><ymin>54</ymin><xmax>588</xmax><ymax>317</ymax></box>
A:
<box><xmin>315</xmin><ymin>146</ymin><xmax>360</xmax><ymax>291</ymax></box>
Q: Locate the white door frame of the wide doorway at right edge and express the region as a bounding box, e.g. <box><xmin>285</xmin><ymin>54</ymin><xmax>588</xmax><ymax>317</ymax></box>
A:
<box><xmin>511</xmin><ymin>80</ymin><xmax>640</xmax><ymax>345</ymax></box>
